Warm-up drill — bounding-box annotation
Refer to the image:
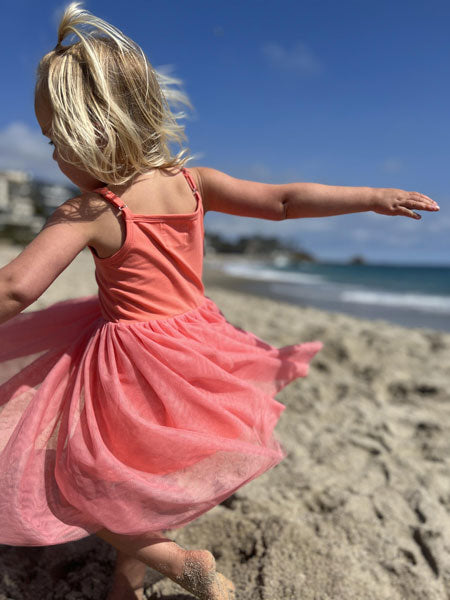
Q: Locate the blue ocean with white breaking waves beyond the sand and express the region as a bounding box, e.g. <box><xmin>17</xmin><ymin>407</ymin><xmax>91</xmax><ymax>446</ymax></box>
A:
<box><xmin>209</xmin><ymin>255</ymin><xmax>450</xmax><ymax>331</ymax></box>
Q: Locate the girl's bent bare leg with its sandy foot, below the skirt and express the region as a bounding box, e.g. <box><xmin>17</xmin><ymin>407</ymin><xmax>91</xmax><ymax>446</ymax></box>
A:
<box><xmin>97</xmin><ymin>529</ymin><xmax>235</xmax><ymax>600</ymax></box>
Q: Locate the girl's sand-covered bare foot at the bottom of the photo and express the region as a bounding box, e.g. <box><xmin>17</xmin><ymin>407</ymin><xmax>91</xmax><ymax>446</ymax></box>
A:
<box><xmin>173</xmin><ymin>550</ymin><xmax>235</xmax><ymax>600</ymax></box>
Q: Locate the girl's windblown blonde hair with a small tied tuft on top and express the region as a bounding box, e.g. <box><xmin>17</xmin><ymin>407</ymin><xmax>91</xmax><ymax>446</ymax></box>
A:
<box><xmin>35</xmin><ymin>2</ymin><xmax>190</xmax><ymax>184</ymax></box>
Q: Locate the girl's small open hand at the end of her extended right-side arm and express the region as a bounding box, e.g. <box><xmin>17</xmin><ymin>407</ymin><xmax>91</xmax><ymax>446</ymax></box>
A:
<box><xmin>372</xmin><ymin>188</ymin><xmax>439</xmax><ymax>219</ymax></box>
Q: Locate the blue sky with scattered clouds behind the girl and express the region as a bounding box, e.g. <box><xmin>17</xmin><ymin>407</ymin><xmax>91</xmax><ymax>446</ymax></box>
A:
<box><xmin>0</xmin><ymin>0</ymin><xmax>450</xmax><ymax>264</ymax></box>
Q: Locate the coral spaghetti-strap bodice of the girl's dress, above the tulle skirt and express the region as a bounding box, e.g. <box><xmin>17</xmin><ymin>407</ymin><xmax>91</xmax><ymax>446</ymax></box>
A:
<box><xmin>90</xmin><ymin>169</ymin><xmax>204</xmax><ymax>322</ymax></box>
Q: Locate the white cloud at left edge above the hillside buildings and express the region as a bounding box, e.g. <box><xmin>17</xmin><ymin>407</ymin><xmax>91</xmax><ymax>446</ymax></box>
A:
<box><xmin>0</xmin><ymin>122</ymin><xmax>68</xmax><ymax>183</ymax></box>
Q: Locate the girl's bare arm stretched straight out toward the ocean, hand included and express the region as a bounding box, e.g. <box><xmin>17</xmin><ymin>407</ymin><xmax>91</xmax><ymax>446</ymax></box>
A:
<box><xmin>192</xmin><ymin>167</ymin><xmax>439</xmax><ymax>221</ymax></box>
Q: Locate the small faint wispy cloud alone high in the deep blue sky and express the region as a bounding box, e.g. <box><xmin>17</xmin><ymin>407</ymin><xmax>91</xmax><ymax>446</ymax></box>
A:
<box><xmin>262</xmin><ymin>42</ymin><xmax>323</xmax><ymax>75</ymax></box>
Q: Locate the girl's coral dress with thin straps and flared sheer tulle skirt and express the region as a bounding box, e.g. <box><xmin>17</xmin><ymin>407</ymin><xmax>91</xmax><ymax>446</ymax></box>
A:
<box><xmin>0</xmin><ymin>170</ymin><xmax>321</xmax><ymax>546</ymax></box>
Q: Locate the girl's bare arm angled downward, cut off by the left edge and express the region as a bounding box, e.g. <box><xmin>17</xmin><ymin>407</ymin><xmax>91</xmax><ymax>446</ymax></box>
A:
<box><xmin>0</xmin><ymin>198</ymin><xmax>97</xmax><ymax>323</ymax></box>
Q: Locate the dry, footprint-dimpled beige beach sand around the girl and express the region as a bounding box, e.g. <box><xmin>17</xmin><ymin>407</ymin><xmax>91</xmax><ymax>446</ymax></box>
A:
<box><xmin>0</xmin><ymin>248</ymin><xmax>450</xmax><ymax>600</ymax></box>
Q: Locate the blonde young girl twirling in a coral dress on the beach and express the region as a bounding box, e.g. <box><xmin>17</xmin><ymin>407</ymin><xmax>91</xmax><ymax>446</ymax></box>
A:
<box><xmin>0</xmin><ymin>3</ymin><xmax>438</xmax><ymax>600</ymax></box>
